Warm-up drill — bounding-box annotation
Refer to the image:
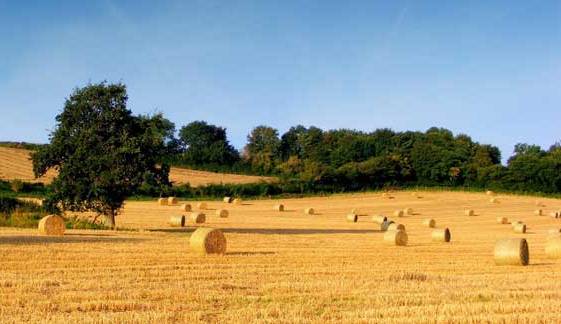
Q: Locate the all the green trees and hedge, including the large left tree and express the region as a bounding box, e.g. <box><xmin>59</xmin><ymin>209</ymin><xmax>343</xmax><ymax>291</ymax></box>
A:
<box><xmin>32</xmin><ymin>82</ymin><xmax>561</xmax><ymax>227</ymax></box>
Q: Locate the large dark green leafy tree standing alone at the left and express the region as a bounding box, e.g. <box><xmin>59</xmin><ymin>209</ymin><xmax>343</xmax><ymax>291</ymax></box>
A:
<box><xmin>32</xmin><ymin>83</ymin><xmax>169</xmax><ymax>228</ymax></box>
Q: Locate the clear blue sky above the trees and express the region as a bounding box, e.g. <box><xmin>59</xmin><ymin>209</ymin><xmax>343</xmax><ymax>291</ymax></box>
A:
<box><xmin>0</xmin><ymin>0</ymin><xmax>561</xmax><ymax>159</ymax></box>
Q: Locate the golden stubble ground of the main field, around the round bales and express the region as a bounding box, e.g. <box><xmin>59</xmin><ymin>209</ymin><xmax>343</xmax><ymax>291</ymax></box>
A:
<box><xmin>0</xmin><ymin>192</ymin><xmax>561</xmax><ymax>323</ymax></box>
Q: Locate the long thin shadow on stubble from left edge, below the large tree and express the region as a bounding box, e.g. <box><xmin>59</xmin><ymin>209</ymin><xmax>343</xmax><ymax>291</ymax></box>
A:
<box><xmin>0</xmin><ymin>234</ymin><xmax>146</xmax><ymax>245</ymax></box>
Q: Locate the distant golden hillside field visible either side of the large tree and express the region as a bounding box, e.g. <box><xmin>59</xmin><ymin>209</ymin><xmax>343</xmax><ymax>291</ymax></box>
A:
<box><xmin>0</xmin><ymin>147</ymin><xmax>274</xmax><ymax>187</ymax></box>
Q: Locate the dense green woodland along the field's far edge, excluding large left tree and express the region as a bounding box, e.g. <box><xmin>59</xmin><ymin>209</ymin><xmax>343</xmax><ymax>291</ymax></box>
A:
<box><xmin>169</xmin><ymin>121</ymin><xmax>561</xmax><ymax>193</ymax></box>
